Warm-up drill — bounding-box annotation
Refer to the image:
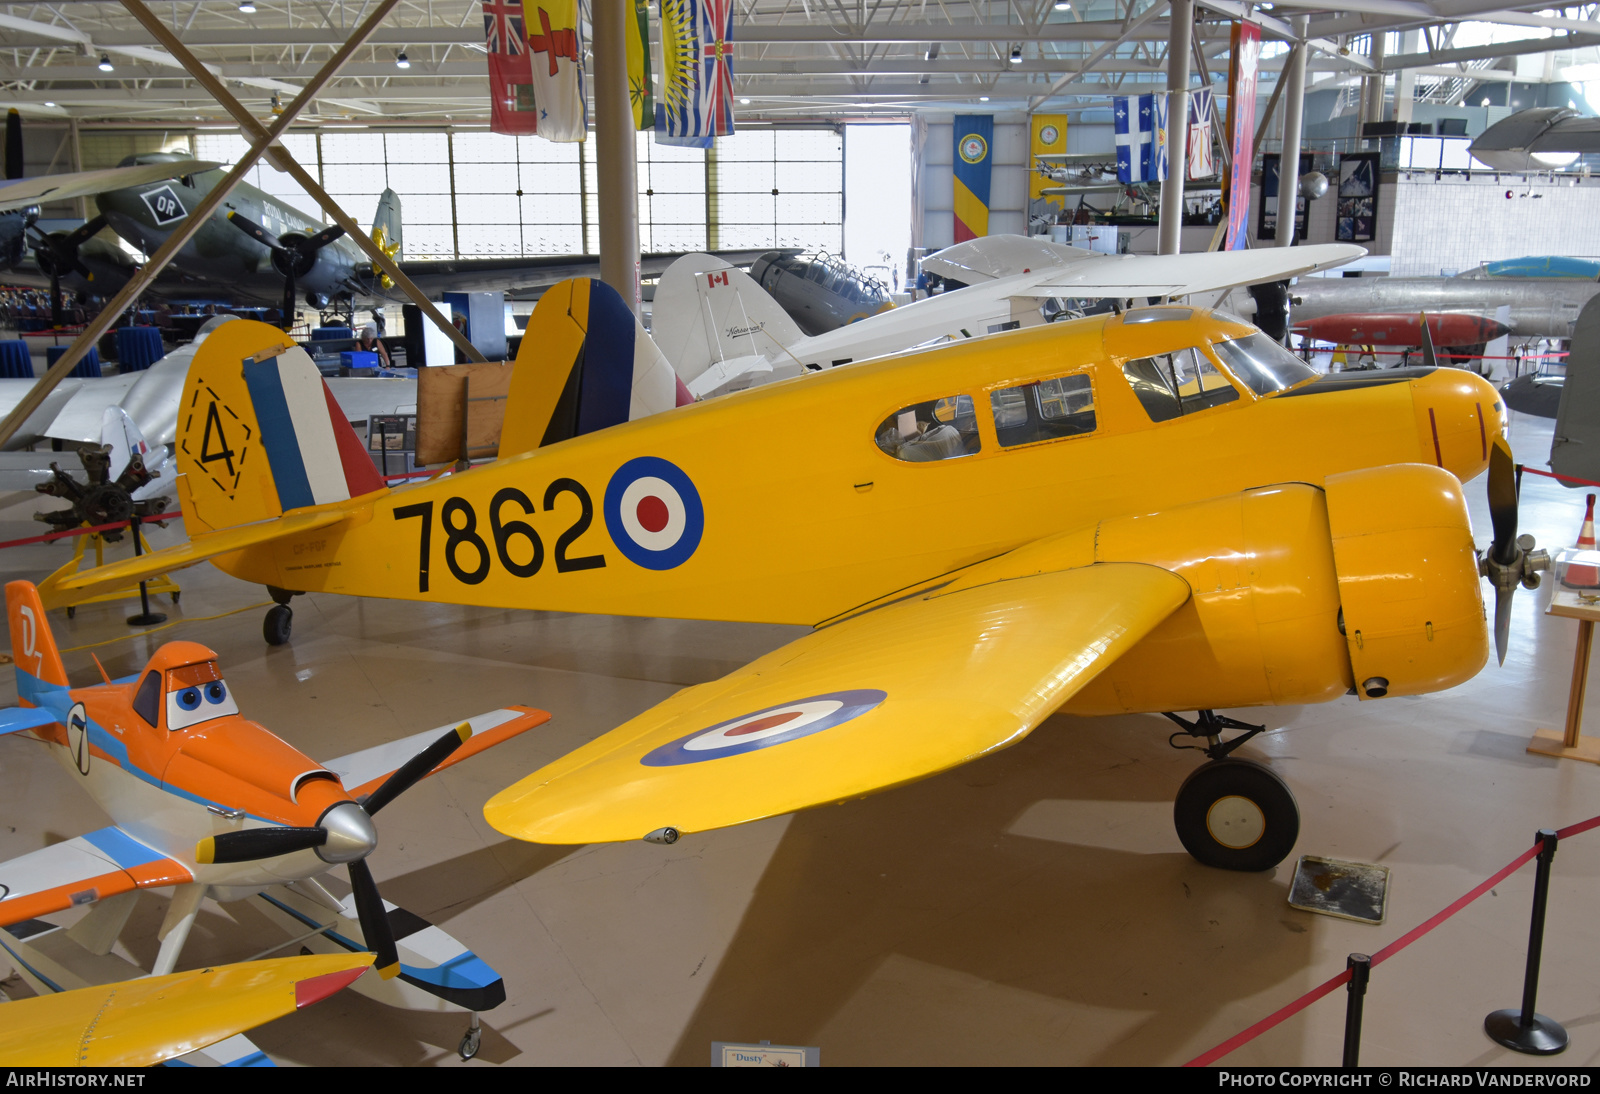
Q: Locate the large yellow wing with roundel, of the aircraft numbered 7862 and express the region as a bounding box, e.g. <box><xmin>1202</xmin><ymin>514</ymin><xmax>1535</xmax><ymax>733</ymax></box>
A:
<box><xmin>483</xmin><ymin>552</ymin><xmax>1189</xmax><ymax>843</ymax></box>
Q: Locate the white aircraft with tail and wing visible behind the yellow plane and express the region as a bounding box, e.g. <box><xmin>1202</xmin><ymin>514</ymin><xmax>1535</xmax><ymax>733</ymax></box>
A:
<box><xmin>651</xmin><ymin>235</ymin><xmax>1366</xmax><ymax>398</ymax></box>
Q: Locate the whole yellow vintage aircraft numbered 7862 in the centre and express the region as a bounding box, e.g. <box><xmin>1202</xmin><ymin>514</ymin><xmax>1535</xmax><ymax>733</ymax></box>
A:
<box><xmin>40</xmin><ymin>281</ymin><xmax>1542</xmax><ymax>870</ymax></box>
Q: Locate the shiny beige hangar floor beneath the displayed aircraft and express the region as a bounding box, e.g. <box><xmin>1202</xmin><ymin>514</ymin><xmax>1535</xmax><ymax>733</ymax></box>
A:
<box><xmin>0</xmin><ymin>406</ymin><xmax>1600</xmax><ymax>1065</ymax></box>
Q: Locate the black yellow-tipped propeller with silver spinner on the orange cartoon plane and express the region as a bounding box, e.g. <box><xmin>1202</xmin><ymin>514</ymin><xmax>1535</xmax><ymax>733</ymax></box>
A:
<box><xmin>195</xmin><ymin>723</ymin><xmax>472</xmax><ymax>979</ymax></box>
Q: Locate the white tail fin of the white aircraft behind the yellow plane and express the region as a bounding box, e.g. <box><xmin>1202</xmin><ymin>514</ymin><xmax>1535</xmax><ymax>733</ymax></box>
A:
<box><xmin>651</xmin><ymin>254</ymin><xmax>805</xmax><ymax>382</ymax></box>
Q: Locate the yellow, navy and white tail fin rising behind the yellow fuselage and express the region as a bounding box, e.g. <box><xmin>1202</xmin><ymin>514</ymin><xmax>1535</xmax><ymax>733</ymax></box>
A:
<box><xmin>499</xmin><ymin>277</ymin><xmax>693</xmax><ymax>459</ymax></box>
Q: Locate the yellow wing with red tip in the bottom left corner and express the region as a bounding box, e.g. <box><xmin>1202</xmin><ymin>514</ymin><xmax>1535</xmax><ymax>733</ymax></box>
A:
<box><xmin>0</xmin><ymin>953</ymin><xmax>373</xmax><ymax>1067</ymax></box>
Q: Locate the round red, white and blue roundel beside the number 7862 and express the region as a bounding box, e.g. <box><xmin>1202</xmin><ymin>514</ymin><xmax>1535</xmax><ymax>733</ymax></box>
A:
<box><xmin>605</xmin><ymin>456</ymin><xmax>706</xmax><ymax>569</ymax></box>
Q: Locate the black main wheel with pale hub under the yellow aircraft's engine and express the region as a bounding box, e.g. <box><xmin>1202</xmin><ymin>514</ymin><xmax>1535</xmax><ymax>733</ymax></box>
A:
<box><xmin>1173</xmin><ymin>760</ymin><xmax>1299</xmax><ymax>870</ymax></box>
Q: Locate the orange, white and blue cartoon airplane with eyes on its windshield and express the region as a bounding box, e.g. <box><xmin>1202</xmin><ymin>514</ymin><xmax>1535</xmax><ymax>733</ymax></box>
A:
<box><xmin>0</xmin><ymin>581</ymin><xmax>549</xmax><ymax>1056</ymax></box>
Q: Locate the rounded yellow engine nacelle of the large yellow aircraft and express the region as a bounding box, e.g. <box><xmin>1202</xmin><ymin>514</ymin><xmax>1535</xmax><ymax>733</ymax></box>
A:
<box><xmin>1064</xmin><ymin>464</ymin><xmax>1488</xmax><ymax>715</ymax></box>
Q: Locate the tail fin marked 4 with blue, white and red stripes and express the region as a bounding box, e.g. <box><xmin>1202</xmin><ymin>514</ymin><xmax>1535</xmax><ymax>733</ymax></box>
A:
<box><xmin>176</xmin><ymin>320</ymin><xmax>384</xmax><ymax>536</ymax></box>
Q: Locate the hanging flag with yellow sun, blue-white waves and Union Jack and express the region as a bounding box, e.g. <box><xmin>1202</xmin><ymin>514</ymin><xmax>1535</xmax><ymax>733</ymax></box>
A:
<box><xmin>656</xmin><ymin>0</ymin><xmax>733</xmax><ymax>149</ymax></box>
